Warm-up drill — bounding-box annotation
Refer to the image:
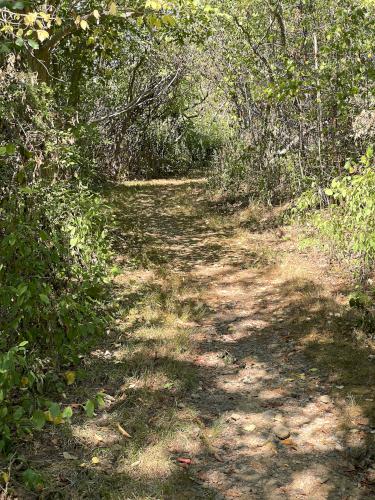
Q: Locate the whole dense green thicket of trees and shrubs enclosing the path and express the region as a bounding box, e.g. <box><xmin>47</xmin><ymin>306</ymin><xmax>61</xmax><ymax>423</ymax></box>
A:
<box><xmin>0</xmin><ymin>0</ymin><xmax>375</xmax><ymax>468</ymax></box>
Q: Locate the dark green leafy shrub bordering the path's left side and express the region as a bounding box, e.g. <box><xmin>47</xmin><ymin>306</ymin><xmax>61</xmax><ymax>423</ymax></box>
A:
<box><xmin>0</xmin><ymin>181</ymin><xmax>112</xmax><ymax>452</ymax></box>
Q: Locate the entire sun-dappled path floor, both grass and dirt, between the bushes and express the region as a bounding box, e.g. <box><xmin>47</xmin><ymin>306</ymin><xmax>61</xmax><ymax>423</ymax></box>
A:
<box><xmin>29</xmin><ymin>180</ymin><xmax>375</xmax><ymax>500</ymax></box>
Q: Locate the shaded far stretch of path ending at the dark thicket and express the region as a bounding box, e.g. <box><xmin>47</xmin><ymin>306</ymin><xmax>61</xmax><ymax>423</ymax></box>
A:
<box><xmin>107</xmin><ymin>179</ymin><xmax>235</xmax><ymax>272</ymax></box>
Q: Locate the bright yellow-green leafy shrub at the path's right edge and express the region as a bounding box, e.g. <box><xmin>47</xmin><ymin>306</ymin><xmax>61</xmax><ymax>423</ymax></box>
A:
<box><xmin>295</xmin><ymin>147</ymin><xmax>375</xmax><ymax>331</ymax></box>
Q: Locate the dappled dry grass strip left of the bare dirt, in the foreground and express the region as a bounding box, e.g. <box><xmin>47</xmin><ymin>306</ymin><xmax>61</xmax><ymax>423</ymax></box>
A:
<box><xmin>21</xmin><ymin>256</ymin><xmax>209</xmax><ymax>499</ymax></box>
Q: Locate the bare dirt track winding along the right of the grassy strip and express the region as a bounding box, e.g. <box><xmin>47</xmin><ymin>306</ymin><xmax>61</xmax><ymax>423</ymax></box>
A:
<box><xmin>111</xmin><ymin>183</ymin><xmax>375</xmax><ymax>499</ymax></box>
